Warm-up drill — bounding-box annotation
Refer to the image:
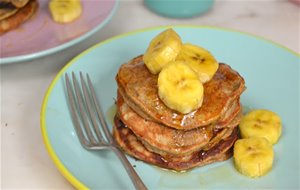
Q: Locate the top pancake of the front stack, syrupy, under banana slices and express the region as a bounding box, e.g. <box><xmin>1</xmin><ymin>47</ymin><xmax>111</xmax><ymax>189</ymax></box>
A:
<box><xmin>116</xmin><ymin>55</ymin><xmax>245</xmax><ymax>130</ymax></box>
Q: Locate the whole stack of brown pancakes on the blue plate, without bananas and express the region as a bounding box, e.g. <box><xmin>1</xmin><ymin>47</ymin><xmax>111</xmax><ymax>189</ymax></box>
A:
<box><xmin>113</xmin><ymin>56</ymin><xmax>245</xmax><ymax>171</ymax></box>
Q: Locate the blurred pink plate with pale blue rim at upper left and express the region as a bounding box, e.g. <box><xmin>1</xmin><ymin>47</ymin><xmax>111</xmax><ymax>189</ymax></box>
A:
<box><xmin>0</xmin><ymin>0</ymin><xmax>118</xmax><ymax>64</ymax></box>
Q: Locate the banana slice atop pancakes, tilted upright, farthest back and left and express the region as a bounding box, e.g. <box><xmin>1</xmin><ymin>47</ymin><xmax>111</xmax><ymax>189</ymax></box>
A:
<box><xmin>143</xmin><ymin>29</ymin><xmax>182</xmax><ymax>74</ymax></box>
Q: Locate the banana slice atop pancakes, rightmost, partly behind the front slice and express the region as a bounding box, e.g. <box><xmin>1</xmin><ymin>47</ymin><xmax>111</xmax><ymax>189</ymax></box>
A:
<box><xmin>176</xmin><ymin>43</ymin><xmax>219</xmax><ymax>83</ymax></box>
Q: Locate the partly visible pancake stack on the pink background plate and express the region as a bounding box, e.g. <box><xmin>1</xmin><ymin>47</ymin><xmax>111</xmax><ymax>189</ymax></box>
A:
<box><xmin>0</xmin><ymin>0</ymin><xmax>38</xmax><ymax>35</ymax></box>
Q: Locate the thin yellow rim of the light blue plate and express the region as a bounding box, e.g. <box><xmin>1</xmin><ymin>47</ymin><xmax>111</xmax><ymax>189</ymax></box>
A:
<box><xmin>40</xmin><ymin>24</ymin><xmax>300</xmax><ymax>189</ymax></box>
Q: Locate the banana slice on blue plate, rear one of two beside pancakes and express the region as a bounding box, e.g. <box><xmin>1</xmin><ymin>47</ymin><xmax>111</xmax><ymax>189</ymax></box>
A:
<box><xmin>239</xmin><ymin>110</ymin><xmax>282</xmax><ymax>144</ymax></box>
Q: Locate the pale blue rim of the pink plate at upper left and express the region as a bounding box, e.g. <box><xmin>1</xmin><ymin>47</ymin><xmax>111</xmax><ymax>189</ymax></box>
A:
<box><xmin>0</xmin><ymin>0</ymin><xmax>120</xmax><ymax>65</ymax></box>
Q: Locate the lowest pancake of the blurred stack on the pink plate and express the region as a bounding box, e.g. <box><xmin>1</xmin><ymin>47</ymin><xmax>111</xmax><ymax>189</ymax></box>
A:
<box><xmin>0</xmin><ymin>0</ymin><xmax>38</xmax><ymax>35</ymax></box>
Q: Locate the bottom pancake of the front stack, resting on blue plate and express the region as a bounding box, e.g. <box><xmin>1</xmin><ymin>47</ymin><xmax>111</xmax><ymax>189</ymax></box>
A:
<box><xmin>113</xmin><ymin>117</ymin><xmax>238</xmax><ymax>171</ymax></box>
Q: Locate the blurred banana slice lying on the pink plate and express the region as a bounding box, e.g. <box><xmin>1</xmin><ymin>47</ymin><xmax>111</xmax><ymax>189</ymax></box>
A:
<box><xmin>49</xmin><ymin>0</ymin><xmax>82</xmax><ymax>23</ymax></box>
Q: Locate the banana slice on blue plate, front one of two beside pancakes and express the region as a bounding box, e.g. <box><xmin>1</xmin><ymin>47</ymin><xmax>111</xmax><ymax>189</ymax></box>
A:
<box><xmin>233</xmin><ymin>138</ymin><xmax>274</xmax><ymax>178</ymax></box>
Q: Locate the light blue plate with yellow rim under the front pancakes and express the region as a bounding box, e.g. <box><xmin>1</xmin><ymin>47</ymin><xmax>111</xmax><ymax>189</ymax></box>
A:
<box><xmin>41</xmin><ymin>26</ymin><xmax>300</xmax><ymax>189</ymax></box>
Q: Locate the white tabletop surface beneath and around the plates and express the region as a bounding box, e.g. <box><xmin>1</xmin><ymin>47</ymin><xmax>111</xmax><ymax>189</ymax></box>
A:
<box><xmin>0</xmin><ymin>0</ymin><xmax>300</xmax><ymax>189</ymax></box>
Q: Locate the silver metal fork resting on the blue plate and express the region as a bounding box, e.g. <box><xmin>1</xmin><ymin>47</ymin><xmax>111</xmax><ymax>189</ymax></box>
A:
<box><xmin>65</xmin><ymin>72</ymin><xmax>147</xmax><ymax>190</ymax></box>
